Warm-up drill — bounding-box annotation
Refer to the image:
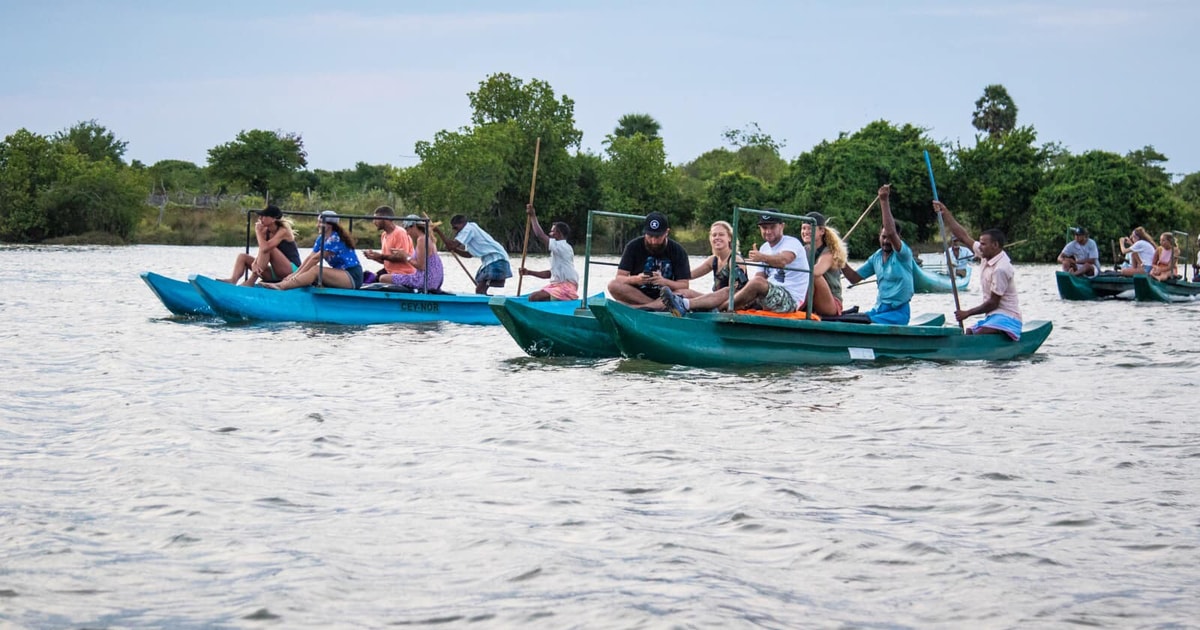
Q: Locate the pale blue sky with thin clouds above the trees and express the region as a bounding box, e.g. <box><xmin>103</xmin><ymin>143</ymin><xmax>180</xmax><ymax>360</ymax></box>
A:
<box><xmin>0</xmin><ymin>0</ymin><xmax>1200</xmax><ymax>175</ymax></box>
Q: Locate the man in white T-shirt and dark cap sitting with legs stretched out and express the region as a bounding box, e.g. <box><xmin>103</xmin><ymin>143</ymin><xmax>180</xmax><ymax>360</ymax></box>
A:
<box><xmin>662</xmin><ymin>210</ymin><xmax>809</xmax><ymax>317</ymax></box>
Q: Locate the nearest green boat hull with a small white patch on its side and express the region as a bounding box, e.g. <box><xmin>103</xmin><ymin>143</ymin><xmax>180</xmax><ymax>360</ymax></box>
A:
<box><xmin>589</xmin><ymin>300</ymin><xmax>1054</xmax><ymax>367</ymax></box>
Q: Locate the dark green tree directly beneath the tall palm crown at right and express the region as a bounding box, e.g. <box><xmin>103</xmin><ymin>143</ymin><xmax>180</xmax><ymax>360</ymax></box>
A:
<box><xmin>947</xmin><ymin>127</ymin><xmax>1054</xmax><ymax>240</ymax></box>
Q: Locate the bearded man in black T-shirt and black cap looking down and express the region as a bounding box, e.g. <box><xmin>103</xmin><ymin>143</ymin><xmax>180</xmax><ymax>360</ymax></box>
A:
<box><xmin>608</xmin><ymin>212</ymin><xmax>691</xmax><ymax>311</ymax></box>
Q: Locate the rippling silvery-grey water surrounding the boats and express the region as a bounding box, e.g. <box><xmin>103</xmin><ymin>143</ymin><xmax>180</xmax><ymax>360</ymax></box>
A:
<box><xmin>0</xmin><ymin>246</ymin><xmax>1200</xmax><ymax>628</ymax></box>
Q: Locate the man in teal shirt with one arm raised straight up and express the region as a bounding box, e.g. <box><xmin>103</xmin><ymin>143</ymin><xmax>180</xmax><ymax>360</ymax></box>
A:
<box><xmin>841</xmin><ymin>185</ymin><xmax>913</xmax><ymax>326</ymax></box>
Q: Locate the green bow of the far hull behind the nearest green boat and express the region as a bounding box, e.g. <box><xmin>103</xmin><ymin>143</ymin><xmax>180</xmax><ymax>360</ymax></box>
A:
<box><xmin>488</xmin><ymin>294</ymin><xmax>620</xmax><ymax>359</ymax></box>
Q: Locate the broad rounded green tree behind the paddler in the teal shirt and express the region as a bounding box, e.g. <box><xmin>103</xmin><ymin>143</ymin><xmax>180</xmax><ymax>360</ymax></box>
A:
<box><xmin>775</xmin><ymin>120</ymin><xmax>948</xmax><ymax>257</ymax></box>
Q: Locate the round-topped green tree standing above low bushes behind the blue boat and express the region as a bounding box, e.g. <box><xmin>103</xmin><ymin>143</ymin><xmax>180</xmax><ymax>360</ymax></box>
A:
<box><xmin>209</xmin><ymin>130</ymin><xmax>308</xmax><ymax>196</ymax></box>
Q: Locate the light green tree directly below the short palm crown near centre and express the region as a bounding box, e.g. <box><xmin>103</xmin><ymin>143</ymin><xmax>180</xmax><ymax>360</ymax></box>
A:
<box><xmin>602</xmin><ymin>133</ymin><xmax>692</xmax><ymax>224</ymax></box>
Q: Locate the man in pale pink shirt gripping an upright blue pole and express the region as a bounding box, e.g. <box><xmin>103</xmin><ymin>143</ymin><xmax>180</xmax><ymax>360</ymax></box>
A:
<box><xmin>934</xmin><ymin>200</ymin><xmax>1021</xmax><ymax>341</ymax></box>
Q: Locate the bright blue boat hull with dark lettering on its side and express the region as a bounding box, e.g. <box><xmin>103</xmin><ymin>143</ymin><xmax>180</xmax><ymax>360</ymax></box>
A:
<box><xmin>188</xmin><ymin>276</ymin><xmax>576</xmax><ymax>325</ymax></box>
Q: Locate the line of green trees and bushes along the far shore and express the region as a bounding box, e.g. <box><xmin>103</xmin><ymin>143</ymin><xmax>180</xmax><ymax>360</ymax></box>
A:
<box><xmin>0</xmin><ymin>73</ymin><xmax>1200</xmax><ymax>260</ymax></box>
